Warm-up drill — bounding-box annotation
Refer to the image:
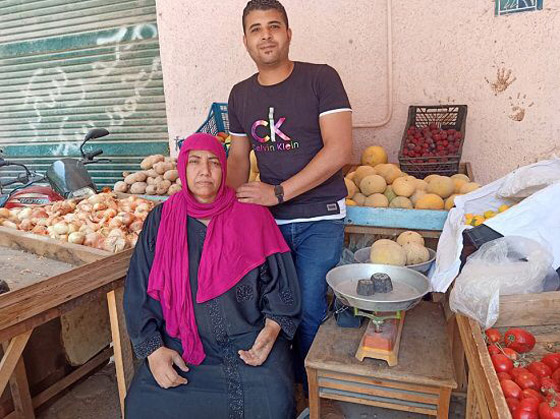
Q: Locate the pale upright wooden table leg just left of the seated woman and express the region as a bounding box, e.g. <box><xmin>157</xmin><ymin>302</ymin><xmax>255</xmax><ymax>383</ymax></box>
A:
<box><xmin>107</xmin><ymin>288</ymin><xmax>134</xmax><ymax>418</ymax></box>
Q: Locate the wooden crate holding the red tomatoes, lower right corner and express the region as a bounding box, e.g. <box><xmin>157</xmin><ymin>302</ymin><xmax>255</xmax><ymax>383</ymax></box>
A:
<box><xmin>457</xmin><ymin>292</ymin><xmax>560</xmax><ymax>419</ymax></box>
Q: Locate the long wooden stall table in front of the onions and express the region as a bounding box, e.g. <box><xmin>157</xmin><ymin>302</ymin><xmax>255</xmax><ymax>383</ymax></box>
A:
<box><xmin>0</xmin><ymin>227</ymin><xmax>134</xmax><ymax>418</ymax></box>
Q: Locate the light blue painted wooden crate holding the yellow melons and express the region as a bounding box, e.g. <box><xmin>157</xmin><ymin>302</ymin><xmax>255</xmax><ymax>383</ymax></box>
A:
<box><xmin>344</xmin><ymin>163</ymin><xmax>474</xmax><ymax>238</ymax></box>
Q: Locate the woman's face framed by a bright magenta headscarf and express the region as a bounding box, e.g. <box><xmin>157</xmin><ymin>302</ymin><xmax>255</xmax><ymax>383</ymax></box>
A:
<box><xmin>187</xmin><ymin>150</ymin><xmax>222</xmax><ymax>204</ymax></box>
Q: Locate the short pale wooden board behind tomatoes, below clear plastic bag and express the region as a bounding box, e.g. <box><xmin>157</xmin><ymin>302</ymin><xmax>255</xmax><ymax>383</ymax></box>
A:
<box><xmin>494</xmin><ymin>291</ymin><xmax>560</xmax><ymax>327</ymax></box>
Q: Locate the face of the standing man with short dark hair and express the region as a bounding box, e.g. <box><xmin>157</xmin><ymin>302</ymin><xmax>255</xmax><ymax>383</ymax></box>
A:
<box><xmin>243</xmin><ymin>9</ymin><xmax>292</xmax><ymax>67</ymax></box>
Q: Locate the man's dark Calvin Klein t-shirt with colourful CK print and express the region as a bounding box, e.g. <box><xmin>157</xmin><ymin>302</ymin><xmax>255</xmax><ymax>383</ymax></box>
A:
<box><xmin>228</xmin><ymin>62</ymin><xmax>351</xmax><ymax>220</ymax></box>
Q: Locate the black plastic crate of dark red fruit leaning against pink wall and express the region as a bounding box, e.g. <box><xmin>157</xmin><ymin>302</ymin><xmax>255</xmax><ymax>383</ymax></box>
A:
<box><xmin>399</xmin><ymin>105</ymin><xmax>467</xmax><ymax>179</ymax></box>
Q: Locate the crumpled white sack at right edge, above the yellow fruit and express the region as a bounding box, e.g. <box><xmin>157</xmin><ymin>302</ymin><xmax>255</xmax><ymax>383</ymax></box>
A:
<box><xmin>498</xmin><ymin>158</ymin><xmax>560</xmax><ymax>198</ymax></box>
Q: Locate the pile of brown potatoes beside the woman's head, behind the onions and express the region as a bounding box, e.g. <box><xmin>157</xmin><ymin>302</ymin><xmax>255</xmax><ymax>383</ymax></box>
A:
<box><xmin>113</xmin><ymin>154</ymin><xmax>181</xmax><ymax>195</ymax></box>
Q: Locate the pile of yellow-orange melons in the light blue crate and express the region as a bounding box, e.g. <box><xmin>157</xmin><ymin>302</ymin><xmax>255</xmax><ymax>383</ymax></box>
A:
<box><xmin>344</xmin><ymin>146</ymin><xmax>480</xmax><ymax>210</ymax></box>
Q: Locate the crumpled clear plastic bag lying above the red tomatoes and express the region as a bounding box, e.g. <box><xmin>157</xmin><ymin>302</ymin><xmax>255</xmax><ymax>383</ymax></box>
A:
<box><xmin>449</xmin><ymin>236</ymin><xmax>558</xmax><ymax>329</ymax></box>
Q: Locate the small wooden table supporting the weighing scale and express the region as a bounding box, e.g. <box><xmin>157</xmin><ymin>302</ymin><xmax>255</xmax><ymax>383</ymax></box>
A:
<box><xmin>305</xmin><ymin>301</ymin><xmax>457</xmax><ymax>419</ymax></box>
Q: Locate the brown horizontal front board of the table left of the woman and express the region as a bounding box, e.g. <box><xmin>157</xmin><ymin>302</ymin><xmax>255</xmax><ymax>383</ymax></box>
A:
<box><xmin>0</xmin><ymin>249</ymin><xmax>134</xmax><ymax>338</ymax></box>
